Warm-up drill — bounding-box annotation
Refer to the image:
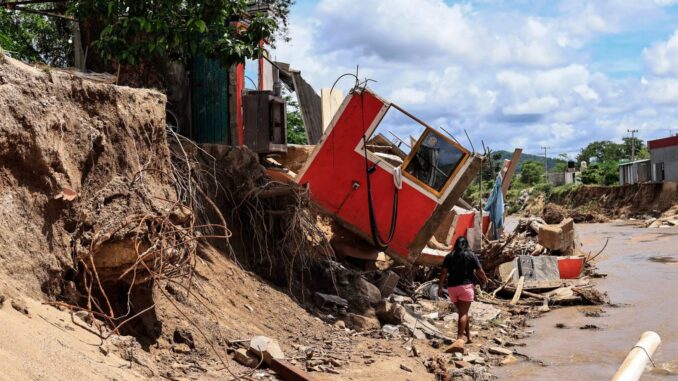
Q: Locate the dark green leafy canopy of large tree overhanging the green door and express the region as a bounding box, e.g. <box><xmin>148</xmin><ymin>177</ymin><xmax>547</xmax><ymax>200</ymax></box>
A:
<box><xmin>71</xmin><ymin>0</ymin><xmax>290</xmax><ymax>66</ymax></box>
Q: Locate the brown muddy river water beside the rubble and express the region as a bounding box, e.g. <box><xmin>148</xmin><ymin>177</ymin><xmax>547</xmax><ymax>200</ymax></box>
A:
<box><xmin>495</xmin><ymin>224</ymin><xmax>678</xmax><ymax>381</ymax></box>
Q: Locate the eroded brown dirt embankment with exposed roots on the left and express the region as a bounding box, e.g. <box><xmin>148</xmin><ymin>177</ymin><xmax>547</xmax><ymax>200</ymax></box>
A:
<box><xmin>0</xmin><ymin>57</ymin><xmax>452</xmax><ymax>380</ymax></box>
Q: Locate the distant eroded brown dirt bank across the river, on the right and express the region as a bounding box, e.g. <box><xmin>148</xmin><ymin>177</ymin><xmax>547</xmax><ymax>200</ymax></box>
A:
<box><xmin>525</xmin><ymin>182</ymin><xmax>678</xmax><ymax>223</ymax></box>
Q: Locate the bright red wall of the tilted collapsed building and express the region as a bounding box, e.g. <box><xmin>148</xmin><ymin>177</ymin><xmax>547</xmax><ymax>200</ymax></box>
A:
<box><xmin>298</xmin><ymin>90</ymin><xmax>438</xmax><ymax>257</ymax></box>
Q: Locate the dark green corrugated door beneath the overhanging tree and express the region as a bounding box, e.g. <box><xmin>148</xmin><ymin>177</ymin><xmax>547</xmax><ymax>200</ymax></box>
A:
<box><xmin>190</xmin><ymin>57</ymin><xmax>230</xmax><ymax>144</ymax></box>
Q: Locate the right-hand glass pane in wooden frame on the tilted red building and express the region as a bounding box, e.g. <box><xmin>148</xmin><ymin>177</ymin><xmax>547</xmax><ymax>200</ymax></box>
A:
<box><xmin>405</xmin><ymin>129</ymin><xmax>464</xmax><ymax>192</ymax></box>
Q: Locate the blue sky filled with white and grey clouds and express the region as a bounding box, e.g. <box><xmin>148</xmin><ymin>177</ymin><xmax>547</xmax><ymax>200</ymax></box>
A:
<box><xmin>272</xmin><ymin>0</ymin><xmax>678</xmax><ymax>158</ymax></box>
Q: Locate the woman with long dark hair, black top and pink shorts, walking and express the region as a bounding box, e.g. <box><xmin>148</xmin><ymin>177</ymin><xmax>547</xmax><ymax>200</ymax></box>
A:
<box><xmin>438</xmin><ymin>237</ymin><xmax>487</xmax><ymax>343</ymax></box>
